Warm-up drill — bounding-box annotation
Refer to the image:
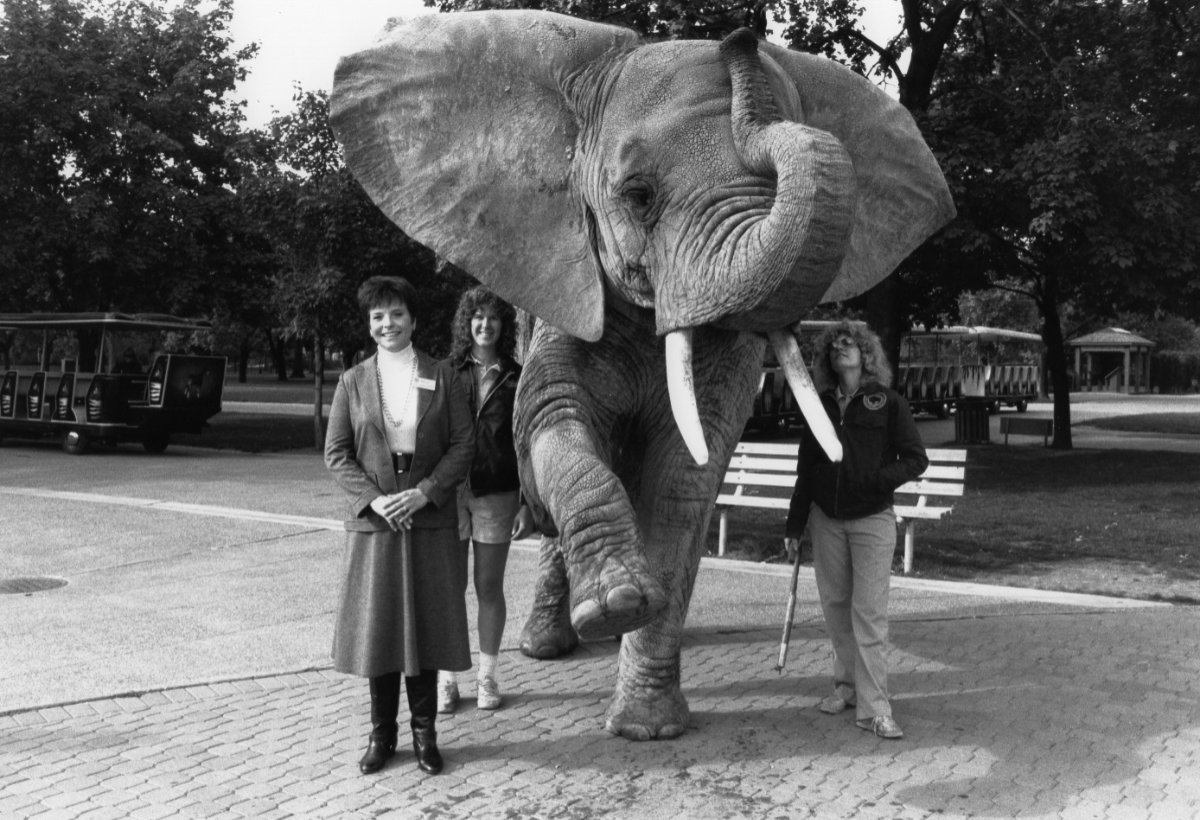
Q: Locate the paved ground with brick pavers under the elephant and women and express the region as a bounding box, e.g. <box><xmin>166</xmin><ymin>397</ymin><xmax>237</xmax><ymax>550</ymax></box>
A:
<box><xmin>0</xmin><ymin>429</ymin><xmax>1200</xmax><ymax>819</ymax></box>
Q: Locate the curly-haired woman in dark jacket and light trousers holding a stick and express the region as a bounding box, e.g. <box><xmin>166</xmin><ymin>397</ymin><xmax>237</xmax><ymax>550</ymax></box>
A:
<box><xmin>785</xmin><ymin>322</ymin><xmax>929</xmax><ymax>740</ymax></box>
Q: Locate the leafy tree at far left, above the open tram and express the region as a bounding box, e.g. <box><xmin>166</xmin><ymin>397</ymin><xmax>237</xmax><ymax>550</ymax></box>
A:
<box><xmin>0</xmin><ymin>0</ymin><xmax>254</xmax><ymax>312</ymax></box>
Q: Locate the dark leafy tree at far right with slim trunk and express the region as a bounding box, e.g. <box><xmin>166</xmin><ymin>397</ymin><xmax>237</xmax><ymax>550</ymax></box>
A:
<box><xmin>930</xmin><ymin>0</ymin><xmax>1200</xmax><ymax>448</ymax></box>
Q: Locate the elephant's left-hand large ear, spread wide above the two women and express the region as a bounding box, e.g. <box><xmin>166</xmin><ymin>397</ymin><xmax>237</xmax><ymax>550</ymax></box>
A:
<box><xmin>330</xmin><ymin>11</ymin><xmax>636</xmax><ymax>340</ymax></box>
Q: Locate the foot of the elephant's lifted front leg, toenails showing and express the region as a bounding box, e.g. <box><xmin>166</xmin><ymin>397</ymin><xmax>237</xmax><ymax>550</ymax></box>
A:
<box><xmin>568</xmin><ymin>551</ymin><xmax>667</xmax><ymax>638</ymax></box>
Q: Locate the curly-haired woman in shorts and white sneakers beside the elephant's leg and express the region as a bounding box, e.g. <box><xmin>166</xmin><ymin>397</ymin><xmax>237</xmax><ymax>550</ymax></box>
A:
<box><xmin>438</xmin><ymin>287</ymin><xmax>532</xmax><ymax>713</ymax></box>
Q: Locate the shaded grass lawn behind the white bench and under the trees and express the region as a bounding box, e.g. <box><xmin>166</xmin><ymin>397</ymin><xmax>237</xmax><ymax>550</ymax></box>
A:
<box><xmin>187</xmin><ymin>403</ymin><xmax>1200</xmax><ymax>604</ymax></box>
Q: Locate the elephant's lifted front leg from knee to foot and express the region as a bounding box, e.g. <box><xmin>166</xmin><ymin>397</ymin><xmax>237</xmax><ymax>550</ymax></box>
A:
<box><xmin>530</xmin><ymin>421</ymin><xmax>667</xmax><ymax>638</ymax></box>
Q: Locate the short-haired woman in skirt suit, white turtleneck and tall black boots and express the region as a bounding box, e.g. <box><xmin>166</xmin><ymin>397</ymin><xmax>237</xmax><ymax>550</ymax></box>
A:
<box><xmin>325</xmin><ymin>276</ymin><xmax>475</xmax><ymax>774</ymax></box>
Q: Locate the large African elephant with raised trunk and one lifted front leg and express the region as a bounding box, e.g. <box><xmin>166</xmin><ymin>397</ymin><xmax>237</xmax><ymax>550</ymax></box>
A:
<box><xmin>330</xmin><ymin>11</ymin><xmax>954</xmax><ymax>740</ymax></box>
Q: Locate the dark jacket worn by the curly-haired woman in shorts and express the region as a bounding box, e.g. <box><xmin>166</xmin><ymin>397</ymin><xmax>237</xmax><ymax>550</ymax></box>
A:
<box><xmin>451</xmin><ymin>355</ymin><xmax>521</xmax><ymax>496</ymax></box>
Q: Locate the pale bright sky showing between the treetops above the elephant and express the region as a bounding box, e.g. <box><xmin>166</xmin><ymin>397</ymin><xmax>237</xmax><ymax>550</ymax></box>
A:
<box><xmin>230</xmin><ymin>0</ymin><xmax>899</xmax><ymax>127</ymax></box>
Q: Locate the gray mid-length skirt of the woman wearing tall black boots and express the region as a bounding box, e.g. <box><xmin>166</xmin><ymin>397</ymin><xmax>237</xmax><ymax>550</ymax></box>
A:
<box><xmin>332</xmin><ymin>527</ymin><xmax>470</xmax><ymax>677</ymax></box>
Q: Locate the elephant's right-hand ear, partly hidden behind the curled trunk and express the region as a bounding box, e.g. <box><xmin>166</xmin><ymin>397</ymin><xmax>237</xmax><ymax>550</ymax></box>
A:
<box><xmin>760</xmin><ymin>43</ymin><xmax>954</xmax><ymax>301</ymax></box>
